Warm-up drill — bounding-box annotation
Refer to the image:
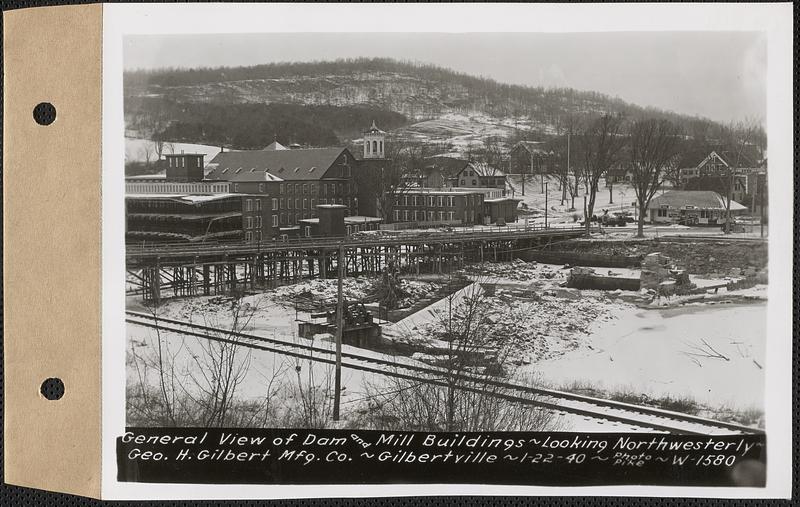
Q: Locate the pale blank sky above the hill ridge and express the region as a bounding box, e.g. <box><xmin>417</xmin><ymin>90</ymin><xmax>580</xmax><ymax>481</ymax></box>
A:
<box><xmin>124</xmin><ymin>31</ymin><xmax>767</xmax><ymax>122</ymax></box>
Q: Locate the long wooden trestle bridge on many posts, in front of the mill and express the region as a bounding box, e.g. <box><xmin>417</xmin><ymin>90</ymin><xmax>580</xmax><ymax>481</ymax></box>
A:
<box><xmin>126</xmin><ymin>226</ymin><xmax>586</xmax><ymax>304</ymax></box>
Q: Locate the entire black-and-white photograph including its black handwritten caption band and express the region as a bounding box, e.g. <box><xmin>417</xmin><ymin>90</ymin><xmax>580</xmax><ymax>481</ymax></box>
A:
<box><xmin>103</xmin><ymin>1</ymin><xmax>792</xmax><ymax>498</ymax></box>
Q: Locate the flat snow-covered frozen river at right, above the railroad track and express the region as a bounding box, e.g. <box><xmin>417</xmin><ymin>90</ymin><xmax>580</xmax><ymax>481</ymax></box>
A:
<box><xmin>530</xmin><ymin>303</ymin><xmax>767</xmax><ymax>409</ymax></box>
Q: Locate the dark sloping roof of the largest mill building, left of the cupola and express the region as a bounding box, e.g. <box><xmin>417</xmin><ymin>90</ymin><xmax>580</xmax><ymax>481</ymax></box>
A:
<box><xmin>206</xmin><ymin>148</ymin><xmax>352</xmax><ymax>181</ymax></box>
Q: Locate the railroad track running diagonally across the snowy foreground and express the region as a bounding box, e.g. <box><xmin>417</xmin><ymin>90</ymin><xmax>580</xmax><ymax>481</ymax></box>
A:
<box><xmin>125</xmin><ymin>311</ymin><xmax>763</xmax><ymax>435</ymax></box>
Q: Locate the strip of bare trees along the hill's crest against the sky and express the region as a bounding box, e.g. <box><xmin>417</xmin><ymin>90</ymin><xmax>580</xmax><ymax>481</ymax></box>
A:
<box><xmin>124</xmin><ymin>58</ymin><xmax>715</xmax><ymax>131</ymax></box>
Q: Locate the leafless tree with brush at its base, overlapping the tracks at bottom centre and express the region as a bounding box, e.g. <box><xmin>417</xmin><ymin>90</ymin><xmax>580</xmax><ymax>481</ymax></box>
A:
<box><xmin>359</xmin><ymin>283</ymin><xmax>555</xmax><ymax>431</ymax></box>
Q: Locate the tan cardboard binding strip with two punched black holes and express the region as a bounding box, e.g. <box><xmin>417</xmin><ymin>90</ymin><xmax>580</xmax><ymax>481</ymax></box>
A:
<box><xmin>3</xmin><ymin>1</ymin><xmax>103</xmax><ymax>498</ymax></box>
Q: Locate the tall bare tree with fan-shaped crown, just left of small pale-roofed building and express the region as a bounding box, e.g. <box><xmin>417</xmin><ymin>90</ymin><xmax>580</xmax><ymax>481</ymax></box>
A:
<box><xmin>628</xmin><ymin>119</ymin><xmax>680</xmax><ymax>238</ymax></box>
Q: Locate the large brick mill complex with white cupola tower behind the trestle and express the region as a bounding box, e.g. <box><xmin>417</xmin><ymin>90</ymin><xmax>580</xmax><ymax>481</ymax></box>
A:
<box><xmin>126</xmin><ymin>122</ymin><xmax>519</xmax><ymax>242</ymax></box>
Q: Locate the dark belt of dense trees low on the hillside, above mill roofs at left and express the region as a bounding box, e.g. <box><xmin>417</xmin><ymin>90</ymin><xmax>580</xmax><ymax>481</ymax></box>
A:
<box><xmin>126</xmin><ymin>98</ymin><xmax>408</xmax><ymax>150</ymax></box>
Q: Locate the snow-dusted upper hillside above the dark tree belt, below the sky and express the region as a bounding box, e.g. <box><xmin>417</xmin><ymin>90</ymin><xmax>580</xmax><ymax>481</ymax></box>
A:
<box><xmin>125</xmin><ymin>58</ymin><xmax>716</xmax><ymax>151</ymax></box>
